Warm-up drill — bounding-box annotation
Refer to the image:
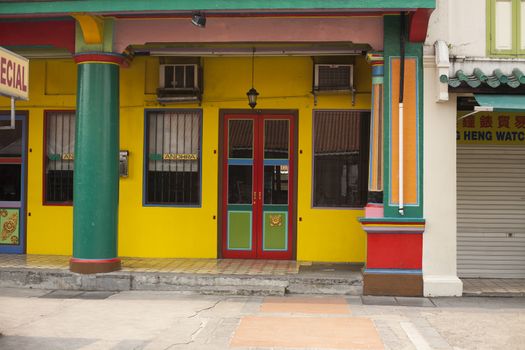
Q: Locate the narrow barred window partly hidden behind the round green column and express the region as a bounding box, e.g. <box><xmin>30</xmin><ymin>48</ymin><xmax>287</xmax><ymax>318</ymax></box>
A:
<box><xmin>44</xmin><ymin>111</ymin><xmax>75</xmax><ymax>204</ymax></box>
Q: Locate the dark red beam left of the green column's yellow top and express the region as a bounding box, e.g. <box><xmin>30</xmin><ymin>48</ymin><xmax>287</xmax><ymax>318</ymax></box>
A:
<box><xmin>0</xmin><ymin>20</ymin><xmax>75</xmax><ymax>53</ymax></box>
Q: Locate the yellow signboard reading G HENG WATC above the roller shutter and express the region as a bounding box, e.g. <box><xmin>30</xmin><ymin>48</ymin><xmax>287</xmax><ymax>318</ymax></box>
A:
<box><xmin>456</xmin><ymin>112</ymin><xmax>525</xmax><ymax>146</ymax></box>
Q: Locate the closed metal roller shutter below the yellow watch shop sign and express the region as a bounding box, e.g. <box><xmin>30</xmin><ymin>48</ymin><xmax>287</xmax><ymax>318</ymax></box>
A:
<box><xmin>457</xmin><ymin>145</ymin><xmax>525</xmax><ymax>278</ymax></box>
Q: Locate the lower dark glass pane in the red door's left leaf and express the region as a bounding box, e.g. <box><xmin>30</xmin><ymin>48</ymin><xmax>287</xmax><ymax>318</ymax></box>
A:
<box><xmin>228</xmin><ymin>165</ymin><xmax>253</xmax><ymax>204</ymax></box>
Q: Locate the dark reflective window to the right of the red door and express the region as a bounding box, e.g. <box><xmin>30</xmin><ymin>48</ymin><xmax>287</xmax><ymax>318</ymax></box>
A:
<box><xmin>313</xmin><ymin>111</ymin><xmax>370</xmax><ymax>207</ymax></box>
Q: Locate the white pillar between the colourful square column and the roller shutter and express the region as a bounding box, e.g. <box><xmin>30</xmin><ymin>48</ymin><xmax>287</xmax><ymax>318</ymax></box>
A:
<box><xmin>423</xmin><ymin>56</ymin><xmax>463</xmax><ymax>296</ymax></box>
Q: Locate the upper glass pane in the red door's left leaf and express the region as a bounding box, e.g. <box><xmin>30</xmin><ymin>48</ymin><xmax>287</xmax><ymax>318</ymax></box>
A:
<box><xmin>228</xmin><ymin>120</ymin><xmax>253</xmax><ymax>158</ymax></box>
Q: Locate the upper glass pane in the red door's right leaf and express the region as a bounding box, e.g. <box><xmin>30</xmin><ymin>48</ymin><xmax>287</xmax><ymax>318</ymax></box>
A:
<box><xmin>264</xmin><ymin>120</ymin><xmax>290</xmax><ymax>159</ymax></box>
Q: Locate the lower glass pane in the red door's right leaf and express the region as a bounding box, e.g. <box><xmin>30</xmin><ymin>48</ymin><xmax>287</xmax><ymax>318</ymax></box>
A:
<box><xmin>264</xmin><ymin>165</ymin><xmax>288</xmax><ymax>204</ymax></box>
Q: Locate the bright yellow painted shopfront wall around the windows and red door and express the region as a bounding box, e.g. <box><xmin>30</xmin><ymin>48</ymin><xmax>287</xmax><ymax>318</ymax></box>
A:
<box><xmin>0</xmin><ymin>57</ymin><xmax>371</xmax><ymax>262</ymax></box>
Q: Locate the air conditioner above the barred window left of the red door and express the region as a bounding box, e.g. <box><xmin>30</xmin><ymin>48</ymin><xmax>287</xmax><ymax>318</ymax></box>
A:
<box><xmin>157</xmin><ymin>64</ymin><xmax>202</xmax><ymax>103</ymax></box>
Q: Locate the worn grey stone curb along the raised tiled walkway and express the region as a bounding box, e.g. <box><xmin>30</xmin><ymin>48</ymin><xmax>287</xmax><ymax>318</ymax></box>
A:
<box><xmin>0</xmin><ymin>268</ymin><xmax>363</xmax><ymax>296</ymax></box>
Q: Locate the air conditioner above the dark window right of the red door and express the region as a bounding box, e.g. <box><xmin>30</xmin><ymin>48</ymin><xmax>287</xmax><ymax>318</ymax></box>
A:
<box><xmin>313</xmin><ymin>64</ymin><xmax>354</xmax><ymax>92</ymax></box>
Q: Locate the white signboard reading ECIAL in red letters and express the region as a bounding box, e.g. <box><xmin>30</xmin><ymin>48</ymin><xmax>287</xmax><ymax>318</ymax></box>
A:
<box><xmin>0</xmin><ymin>47</ymin><xmax>29</xmax><ymax>100</ymax></box>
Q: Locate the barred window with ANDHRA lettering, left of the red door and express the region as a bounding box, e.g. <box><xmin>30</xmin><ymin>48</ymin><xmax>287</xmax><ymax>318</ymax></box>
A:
<box><xmin>145</xmin><ymin>110</ymin><xmax>202</xmax><ymax>206</ymax></box>
